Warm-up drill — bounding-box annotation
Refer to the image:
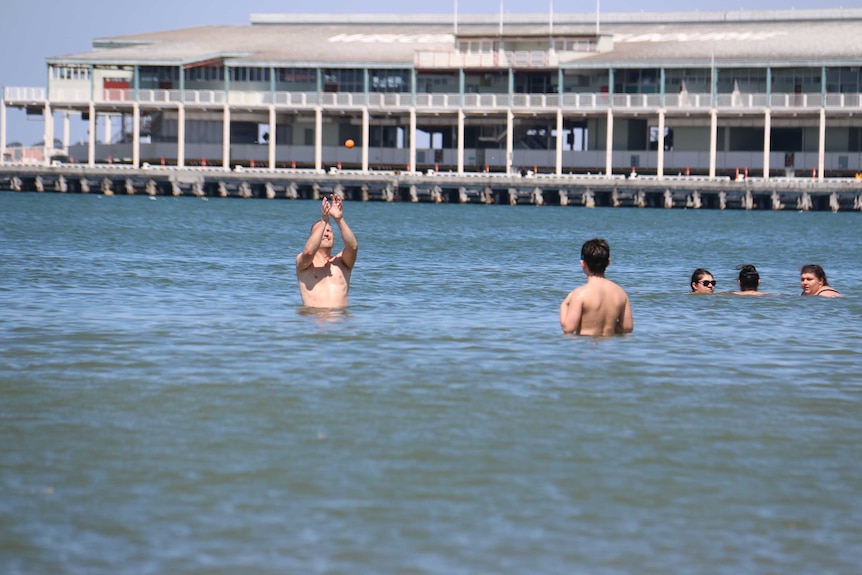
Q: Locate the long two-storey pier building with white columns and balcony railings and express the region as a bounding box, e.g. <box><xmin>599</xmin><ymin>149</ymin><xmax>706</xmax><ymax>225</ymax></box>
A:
<box><xmin>0</xmin><ymin>9</ymin><xmax>862</xmax><ymax>178</ymax></box>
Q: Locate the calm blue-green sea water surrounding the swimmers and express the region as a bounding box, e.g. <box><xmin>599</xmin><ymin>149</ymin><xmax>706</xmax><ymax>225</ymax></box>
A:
<box><xmin>5</xmin><ymin>192</ymin><xmax>862</xmax><ymax>574</ymax></box>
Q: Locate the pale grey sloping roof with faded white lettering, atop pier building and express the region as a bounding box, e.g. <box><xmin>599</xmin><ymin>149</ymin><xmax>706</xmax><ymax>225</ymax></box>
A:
<box><xmin>48</xmin><ymin>9</ymin><xmax>862</xmax><ymax>68</ymax></box>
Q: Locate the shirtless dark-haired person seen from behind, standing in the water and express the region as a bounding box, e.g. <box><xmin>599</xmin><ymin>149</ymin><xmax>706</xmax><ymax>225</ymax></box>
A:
<box><xmin>560</xmin><ymin>238</ymin><xmax>635</xmax><ymax>336</ymax></box>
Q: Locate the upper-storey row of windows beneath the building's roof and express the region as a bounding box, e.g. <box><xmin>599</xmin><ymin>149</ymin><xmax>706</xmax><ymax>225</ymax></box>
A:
<box><xmin>51</xmin><ymin>66</ymin><xmax>862</xmax><ymax>94</ymax></box>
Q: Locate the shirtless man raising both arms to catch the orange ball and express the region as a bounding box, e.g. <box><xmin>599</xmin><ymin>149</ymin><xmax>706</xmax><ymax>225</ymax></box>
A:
<box><xmin>296</xmin><ymin>195</ymin><xmax>359</xmax><ymax>308</ymax></box>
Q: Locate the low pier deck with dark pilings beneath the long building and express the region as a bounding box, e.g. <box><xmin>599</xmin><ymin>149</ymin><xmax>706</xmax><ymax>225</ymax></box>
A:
<box><xmin>0</xmin><ymin>164</ymin><xmax>862</xmax><ymax>211</ymax></box>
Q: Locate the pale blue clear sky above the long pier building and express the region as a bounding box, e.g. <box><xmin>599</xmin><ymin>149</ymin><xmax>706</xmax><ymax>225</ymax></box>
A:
<box><xmin>0</xmin><ymin>0</ymin><xmax>862</xmax><ymax>145</ymax></box>
